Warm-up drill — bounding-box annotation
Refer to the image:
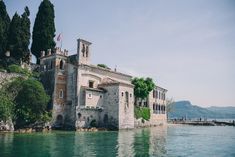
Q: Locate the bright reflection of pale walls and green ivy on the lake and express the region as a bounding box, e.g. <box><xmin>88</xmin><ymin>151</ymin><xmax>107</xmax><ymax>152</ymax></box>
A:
<box><xmin>117</xmin><ymin>127</ymin><xmax>167</xmax><ymax>157</ymax></box>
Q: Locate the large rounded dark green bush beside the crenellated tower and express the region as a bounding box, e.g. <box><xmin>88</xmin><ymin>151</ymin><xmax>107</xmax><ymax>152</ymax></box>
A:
<box><xmin>15</xmin><ymin>79</ymin><xmax>49</xmax><ymax>126</ymax></box>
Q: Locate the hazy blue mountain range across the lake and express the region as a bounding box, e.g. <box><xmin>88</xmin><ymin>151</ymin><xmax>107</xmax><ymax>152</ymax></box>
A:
<box><xmin>169</xmin><ymin>101</ymin><xmax>235</xmax><ymax>119</ymax></box>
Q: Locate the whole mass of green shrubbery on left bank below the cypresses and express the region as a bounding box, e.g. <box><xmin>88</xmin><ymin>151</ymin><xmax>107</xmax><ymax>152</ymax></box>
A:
<box><xmin>0</xmin><ymin>77</ymin><xmax>50</xmax><ymax>128</ymax></box>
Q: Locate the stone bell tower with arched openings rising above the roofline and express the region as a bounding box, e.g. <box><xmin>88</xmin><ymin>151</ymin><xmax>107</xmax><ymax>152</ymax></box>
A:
<box><xmin>77</xmin><ymin>39</ymin><xmax>91</xmax><ymax>64</ymax></box>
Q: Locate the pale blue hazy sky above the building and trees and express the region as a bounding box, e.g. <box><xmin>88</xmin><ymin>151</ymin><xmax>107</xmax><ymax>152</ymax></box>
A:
<box><xmin>5</xmin><ymin>0</ymin><xmax>235</xmax><ymax>107</ymax></box>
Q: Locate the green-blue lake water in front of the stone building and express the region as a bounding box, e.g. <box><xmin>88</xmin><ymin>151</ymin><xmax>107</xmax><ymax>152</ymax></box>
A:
<box><xmin>0</xmin><ymin>125</ymin><xmax>235</xmax><ymax>157</ymax></box>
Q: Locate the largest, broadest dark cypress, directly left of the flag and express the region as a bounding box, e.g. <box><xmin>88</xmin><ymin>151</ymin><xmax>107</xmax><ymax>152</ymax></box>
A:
<box><xmin>31</xmin><ymin>0</ymin><xmax>56</xmax><ymax>63</ymax></box>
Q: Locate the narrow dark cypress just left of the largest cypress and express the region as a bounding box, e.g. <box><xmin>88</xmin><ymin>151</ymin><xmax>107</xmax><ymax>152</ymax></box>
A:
<box><xmin>21</xmin><ymin>6</ymin><xmax>30</xmax><ymax>63</ymax></box>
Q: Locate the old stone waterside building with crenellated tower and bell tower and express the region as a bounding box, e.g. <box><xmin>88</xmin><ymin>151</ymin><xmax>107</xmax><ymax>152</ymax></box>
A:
<box><xmin>40</xmin><ymin>39</ymin><xmax>166</xmax><ymax>129</ymax></box>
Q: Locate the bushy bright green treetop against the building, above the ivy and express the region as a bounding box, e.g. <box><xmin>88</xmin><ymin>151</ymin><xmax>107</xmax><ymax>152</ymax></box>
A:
<box><xmin>132</xmin><ymin>77</ymin><xmax>155</xmax><ymax>99</ymax></box>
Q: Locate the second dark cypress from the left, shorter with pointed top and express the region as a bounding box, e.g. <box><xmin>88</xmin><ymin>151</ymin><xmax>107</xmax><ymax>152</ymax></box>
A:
<box><xmin>7</xmin><ymin>13</ymin><xmax>23</xmax><ymax>64</ymax></box>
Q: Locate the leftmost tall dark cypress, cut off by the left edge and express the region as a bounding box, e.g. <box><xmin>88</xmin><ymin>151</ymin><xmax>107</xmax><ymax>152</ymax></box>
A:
<box><xmin>0</xmin><ymin>1</ymin><xmax>10</xmax><ymax>59</ymax></box>
